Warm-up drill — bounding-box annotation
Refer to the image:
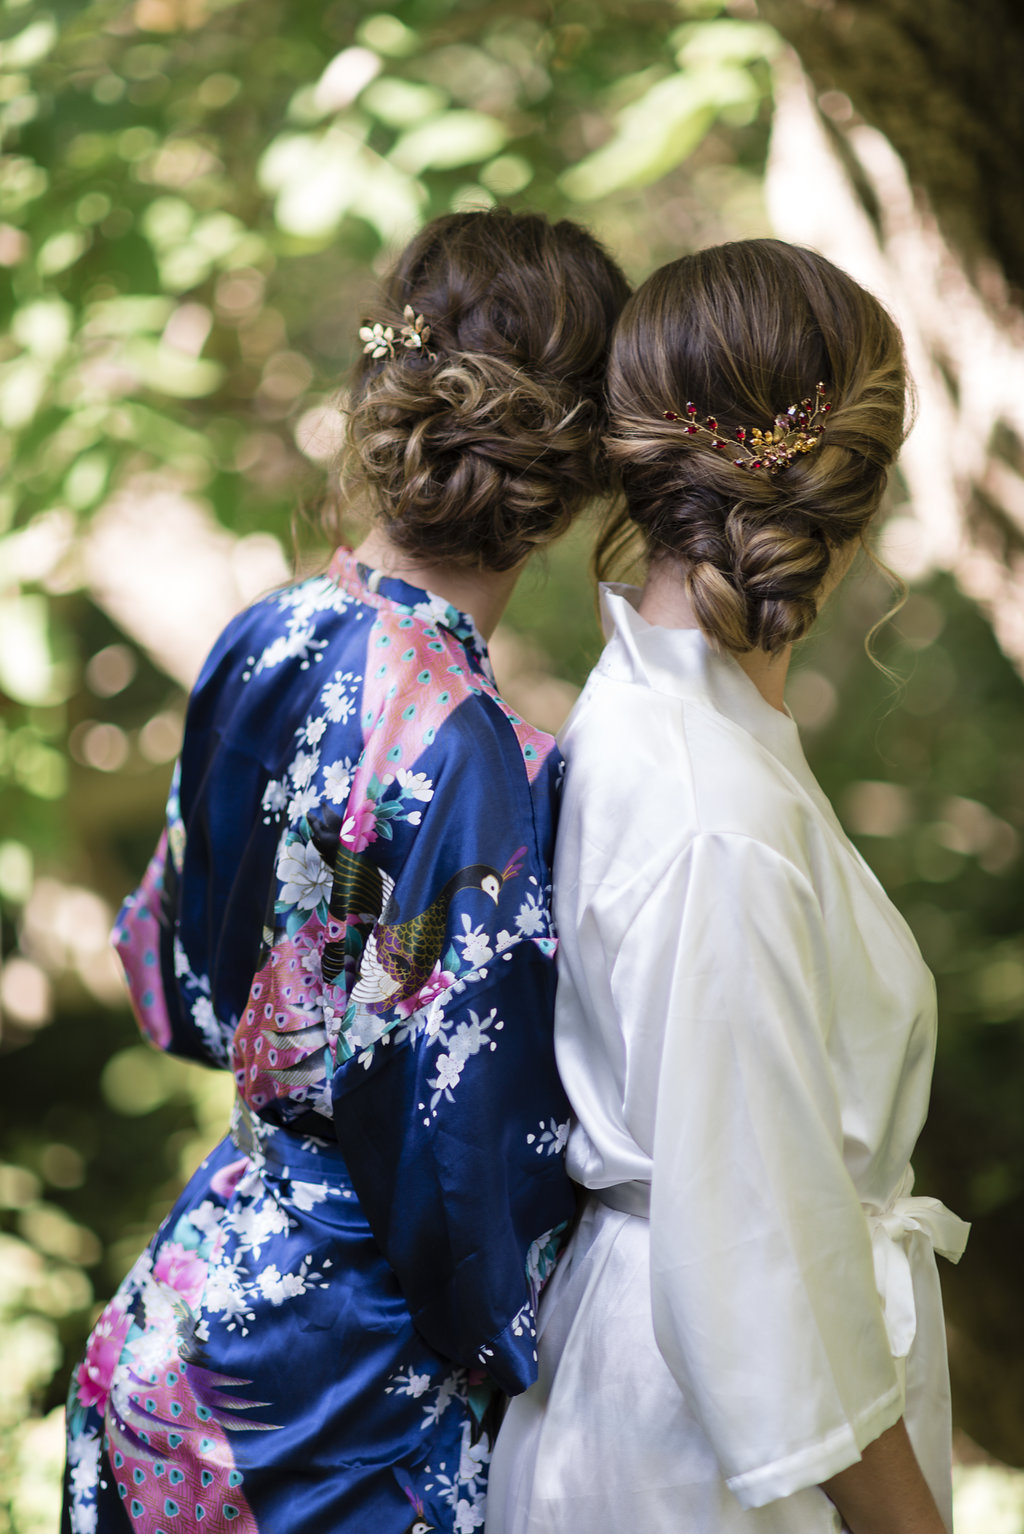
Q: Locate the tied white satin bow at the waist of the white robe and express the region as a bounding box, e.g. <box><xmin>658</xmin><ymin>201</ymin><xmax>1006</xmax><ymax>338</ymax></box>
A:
<box><xmin>865</xmin><ymin>1166</ymin><xmax>970</xmax><ymax>1358</ymax></box>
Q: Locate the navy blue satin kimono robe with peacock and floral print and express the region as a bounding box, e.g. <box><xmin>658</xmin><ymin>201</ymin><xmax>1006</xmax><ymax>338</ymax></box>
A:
<box><xmin>63</xmin><ymin>549</ymin><xmax>573</xmax><ymax>1534</ymax></box>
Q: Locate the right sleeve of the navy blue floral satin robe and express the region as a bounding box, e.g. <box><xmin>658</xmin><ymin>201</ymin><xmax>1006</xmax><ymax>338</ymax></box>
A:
<box><xmin>333</xmin><ymin>710</ymin><xmax>575</xmax><ymax>1394</ymax></box>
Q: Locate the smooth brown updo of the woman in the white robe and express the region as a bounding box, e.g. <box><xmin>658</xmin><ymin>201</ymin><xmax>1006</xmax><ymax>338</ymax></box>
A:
<box><xmin>596</xmin><ymin>239</ymin><xmax>907</xmax><ymax>653</ymax></box>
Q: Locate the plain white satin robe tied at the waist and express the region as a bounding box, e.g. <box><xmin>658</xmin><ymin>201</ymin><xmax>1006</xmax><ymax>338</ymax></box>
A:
<box><xmin>486</xmin><ymin>588</ymin><xmax>967</xmax><ymax>1534</ymax></box>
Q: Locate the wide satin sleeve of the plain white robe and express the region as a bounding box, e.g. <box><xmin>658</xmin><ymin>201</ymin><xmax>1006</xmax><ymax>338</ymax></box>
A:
<box><xmin>643</xmin><ymin>834</ymin><xmax>903</xmax><ymax>1508</ymax></box>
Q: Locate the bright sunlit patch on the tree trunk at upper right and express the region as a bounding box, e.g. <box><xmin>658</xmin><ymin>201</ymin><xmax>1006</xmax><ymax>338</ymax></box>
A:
<box><xmin>766</xmin><ymin>58</ymin><xmax>1024</xmax><ymax>667</ymax></box>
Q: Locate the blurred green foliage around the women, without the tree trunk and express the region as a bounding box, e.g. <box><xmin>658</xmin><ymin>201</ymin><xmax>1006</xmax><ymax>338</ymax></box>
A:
<box><xmin>0</xmin><ymin>0</ymin><xmax>1024</xmax><ymax>1534</ymax></box>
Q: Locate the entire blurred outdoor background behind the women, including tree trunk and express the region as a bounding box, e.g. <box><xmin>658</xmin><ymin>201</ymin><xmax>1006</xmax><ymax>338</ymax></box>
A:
<box><xmin>0</xmin><ymin>0</ymin><xmax>1024</xmax><ymax>1534</ymax></box>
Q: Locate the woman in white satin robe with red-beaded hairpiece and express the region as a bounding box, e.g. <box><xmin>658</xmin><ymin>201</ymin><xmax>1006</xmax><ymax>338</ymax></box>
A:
<box><xmin>487</xmin><ymin>241</ymin><xmax>967</xmax><ymax>1534</ymax></box>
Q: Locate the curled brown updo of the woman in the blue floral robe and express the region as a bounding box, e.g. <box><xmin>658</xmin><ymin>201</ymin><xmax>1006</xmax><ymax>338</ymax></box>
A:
<box><xmin>343</xmin><ymin>209</ymin><xmax>629</xmax><ymax>571</ymax></box>
